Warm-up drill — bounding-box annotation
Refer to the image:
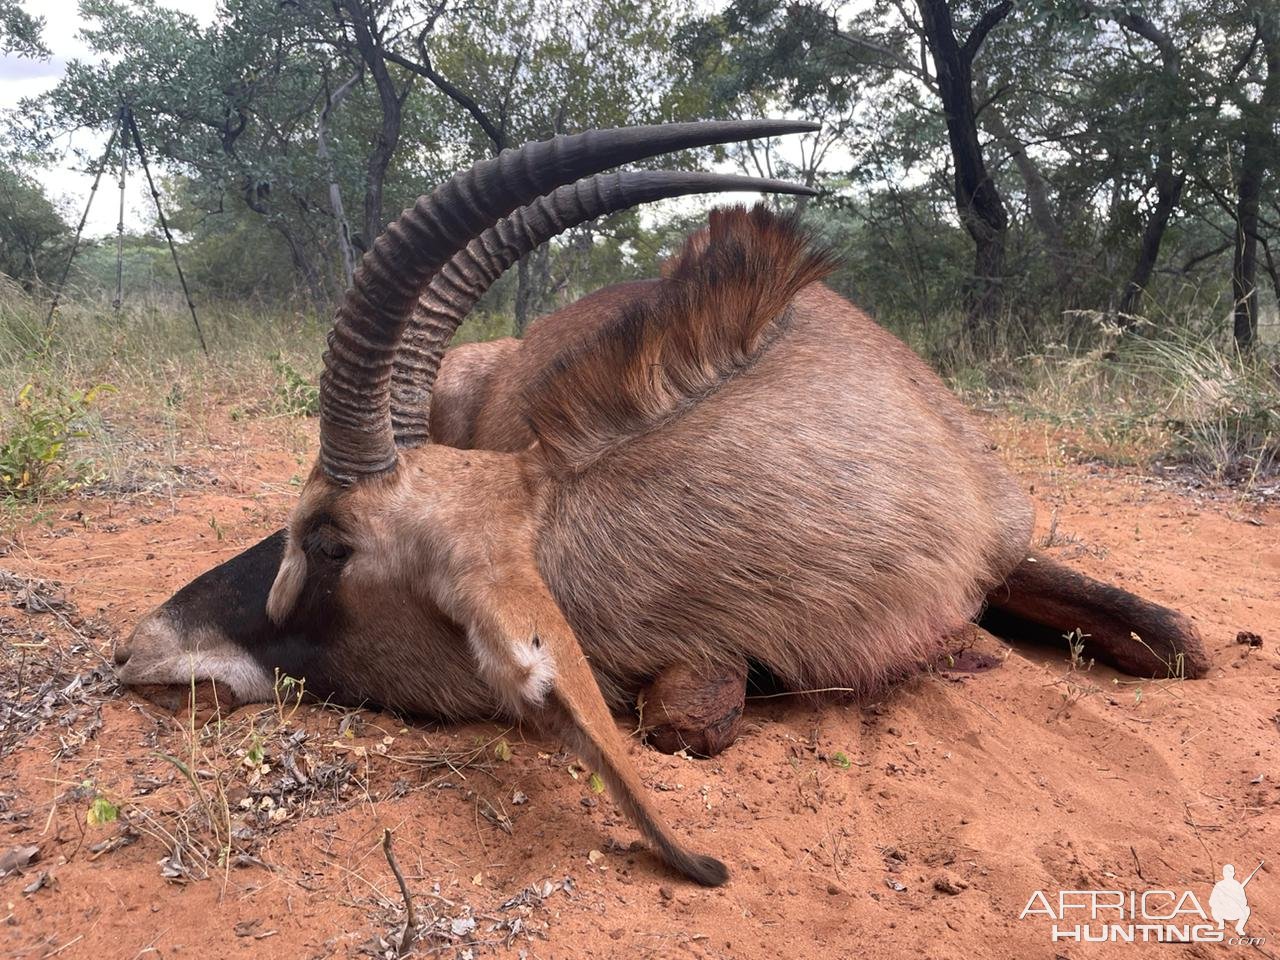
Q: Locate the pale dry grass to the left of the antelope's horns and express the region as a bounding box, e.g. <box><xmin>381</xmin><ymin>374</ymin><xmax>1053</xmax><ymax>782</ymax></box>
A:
<box><xmin>0</xmin><ymin>278</ymin><xmax>511</xmax><ymax>527</ymax></box>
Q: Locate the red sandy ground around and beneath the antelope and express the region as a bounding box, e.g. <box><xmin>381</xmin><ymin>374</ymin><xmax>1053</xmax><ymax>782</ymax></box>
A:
<box><xmin>0</xmin><ymin>409</ymin><xmax>1280</xmax><ymax>960</ymax></box>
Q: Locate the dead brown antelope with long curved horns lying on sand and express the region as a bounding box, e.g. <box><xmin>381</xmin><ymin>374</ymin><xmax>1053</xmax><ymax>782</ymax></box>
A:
<box><xmin>116</xmin><ymin>122</ymin><xmax>1208</xmax><ymax>884</ymax></box>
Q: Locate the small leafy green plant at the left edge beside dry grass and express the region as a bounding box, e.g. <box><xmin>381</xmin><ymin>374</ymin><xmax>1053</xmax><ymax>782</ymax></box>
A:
<box><xmin>0</xmin><ymin>380</ymin><xmax>111</xmax><ymax>499</ymax></box>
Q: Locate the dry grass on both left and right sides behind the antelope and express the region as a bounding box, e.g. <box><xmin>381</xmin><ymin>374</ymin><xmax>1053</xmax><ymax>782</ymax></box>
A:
<box><xmin>0</xmin><ymin>282</ymin><xmax>1280</xmax><ymax>526</ymax></box>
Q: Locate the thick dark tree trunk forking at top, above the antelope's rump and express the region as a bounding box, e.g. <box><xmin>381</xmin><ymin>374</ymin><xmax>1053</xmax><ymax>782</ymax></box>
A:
<box><xmin>916</xmin><ymin>0</ymin><xmax>1012</xmax><ymax>343</ymax></box>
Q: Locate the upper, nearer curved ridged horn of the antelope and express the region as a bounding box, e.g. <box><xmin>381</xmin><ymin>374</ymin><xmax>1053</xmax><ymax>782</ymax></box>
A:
<box><xmin>320</xmin><ymin>120</ymin><xmax>815</xmax><ymax>484</ymax></box>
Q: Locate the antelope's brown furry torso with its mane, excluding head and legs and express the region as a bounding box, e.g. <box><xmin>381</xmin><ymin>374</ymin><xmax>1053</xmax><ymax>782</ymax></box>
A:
<box><xmin>433</xmin><ymin>208</ymin><xmax>1032</xmax><ymax>709</ymax></box>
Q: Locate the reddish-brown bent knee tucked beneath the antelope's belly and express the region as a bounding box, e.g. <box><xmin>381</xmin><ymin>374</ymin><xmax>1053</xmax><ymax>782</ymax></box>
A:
<box><xmin>637</xmin><ymin>662</ymin><xmax>746</xmax><ymax>756</ymax></box>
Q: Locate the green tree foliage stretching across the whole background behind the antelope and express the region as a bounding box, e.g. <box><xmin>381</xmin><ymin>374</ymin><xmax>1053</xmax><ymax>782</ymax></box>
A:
<box><xmin>0</xmin><ymin>0</ymin><xmax>1280</xmax><ymax>358</ymax></box>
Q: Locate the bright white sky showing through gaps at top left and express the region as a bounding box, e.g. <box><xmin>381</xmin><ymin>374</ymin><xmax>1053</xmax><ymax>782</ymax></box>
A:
<box><xmin>0</xmin><ymin>0</ymin><xmax>216</xmax><ymax>237</ymax></box>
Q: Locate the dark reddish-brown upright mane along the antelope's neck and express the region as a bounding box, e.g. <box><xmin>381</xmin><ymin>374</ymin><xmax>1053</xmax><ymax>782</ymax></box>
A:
<box><xmin>524</xmin><ymin>206</ymin><xmax>833</xmax><ymax>474</ymax></box>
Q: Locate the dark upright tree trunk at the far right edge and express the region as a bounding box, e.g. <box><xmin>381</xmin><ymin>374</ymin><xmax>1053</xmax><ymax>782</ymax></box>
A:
<box><xmin>1231</xmin><ymin>14</ymin><xmax>1280</xmax><ymax>351</ymax></box>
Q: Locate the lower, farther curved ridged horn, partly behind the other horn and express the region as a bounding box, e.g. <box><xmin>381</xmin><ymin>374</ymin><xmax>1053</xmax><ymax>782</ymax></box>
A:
<box><xmin>392</xmin><ymin>170</ymin><xmax>817</xmax><ymax>447</ymax></box>
